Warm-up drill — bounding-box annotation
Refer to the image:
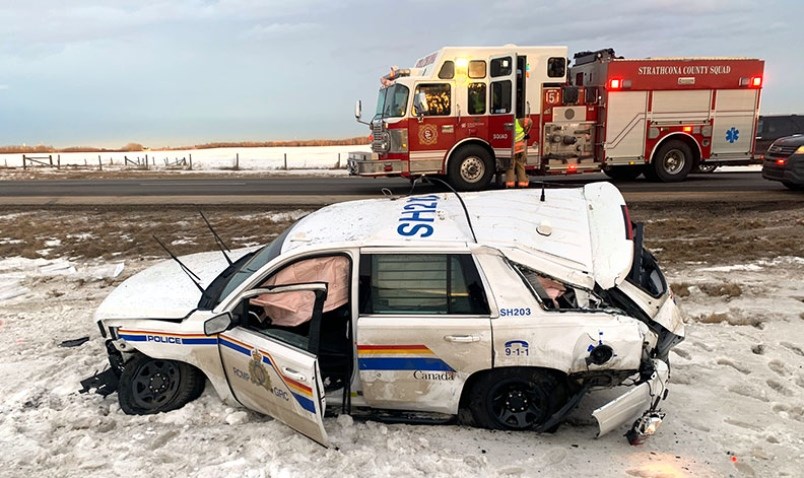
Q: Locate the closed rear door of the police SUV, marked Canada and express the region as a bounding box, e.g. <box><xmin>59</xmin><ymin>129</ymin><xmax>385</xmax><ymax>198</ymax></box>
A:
<box><xmin>356</xmin><ymin>249</ymin><xmax>491</xmax><ymax>414</ymax></box>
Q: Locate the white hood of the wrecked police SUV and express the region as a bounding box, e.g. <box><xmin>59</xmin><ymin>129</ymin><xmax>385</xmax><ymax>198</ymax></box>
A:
<box><xmin>95</xmin><ymin>251</ymin><xmax>235</xmax><ymax>320</ymax></box>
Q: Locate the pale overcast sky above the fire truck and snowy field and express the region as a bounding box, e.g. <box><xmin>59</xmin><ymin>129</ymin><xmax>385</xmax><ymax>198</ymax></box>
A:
<box><xmin>0</xmin><ymin>0</ymin><xmax>804</xmax><ymax>147</ymax></box>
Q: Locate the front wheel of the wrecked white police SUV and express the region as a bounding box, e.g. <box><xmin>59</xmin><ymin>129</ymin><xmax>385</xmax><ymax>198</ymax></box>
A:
<box><xmin>117</xmin><ymin>354</ymin><xmax>206</xmax><ymax>415</ymax></box>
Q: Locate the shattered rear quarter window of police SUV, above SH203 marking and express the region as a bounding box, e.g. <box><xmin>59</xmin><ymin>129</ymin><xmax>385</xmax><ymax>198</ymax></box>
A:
<box><xmin>511</xmin><ymin>263</ymin><xmax>605</xmax><ymax>311</ymax></box>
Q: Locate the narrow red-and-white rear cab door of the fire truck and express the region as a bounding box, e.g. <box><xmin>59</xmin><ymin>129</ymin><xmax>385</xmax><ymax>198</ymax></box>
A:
<box><xmin>489</xmin><ymin>53</ymin><xmax>516</xmax><ymax>158</ymax></box>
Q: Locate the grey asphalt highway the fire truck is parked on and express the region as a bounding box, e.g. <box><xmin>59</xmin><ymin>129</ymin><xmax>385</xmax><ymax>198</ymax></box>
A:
<box><xmin>0</xmin><ymin>172</ymin><xmax>804</xmax><ymax>205</ymax></box>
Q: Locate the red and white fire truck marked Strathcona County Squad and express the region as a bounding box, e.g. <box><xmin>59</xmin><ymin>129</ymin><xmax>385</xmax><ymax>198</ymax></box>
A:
<box><xmin>348</xmin><ymin>45</ymin><xmax>764</xmax><ymax>191</ymax></box>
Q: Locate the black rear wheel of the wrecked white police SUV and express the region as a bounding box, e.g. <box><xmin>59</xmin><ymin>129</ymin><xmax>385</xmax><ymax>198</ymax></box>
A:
<box><xmin>469</xmin><ymin>368</ymin><xmax>567</xmax><ymax>431</ymax></box>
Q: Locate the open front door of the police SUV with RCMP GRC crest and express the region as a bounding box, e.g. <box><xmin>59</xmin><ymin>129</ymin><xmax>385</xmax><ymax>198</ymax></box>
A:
<box><xmin>218</xmin><ymin>283</ymin><xmax>328</xmax><ymax>446</ymax></box>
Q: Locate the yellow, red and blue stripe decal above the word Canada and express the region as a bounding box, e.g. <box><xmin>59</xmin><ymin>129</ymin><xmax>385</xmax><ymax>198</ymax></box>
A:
<box><xmin>357</xmin><ymin>345</ymin><xmax>455</xmax><ymax>372</ymax></box>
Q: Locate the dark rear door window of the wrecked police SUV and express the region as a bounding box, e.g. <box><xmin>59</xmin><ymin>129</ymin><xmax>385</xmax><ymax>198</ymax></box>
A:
<box><xmin>359</xmin><ymin>254</ymin><xmax>489</xmax><ymax>315</ymax></box>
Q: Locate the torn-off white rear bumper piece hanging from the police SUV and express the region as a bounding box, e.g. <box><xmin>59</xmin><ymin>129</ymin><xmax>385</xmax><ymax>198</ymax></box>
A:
<box><xmin>592</xmin><ymin>359</ymin><xmax>670</xmax><ymax>444</ymax></box>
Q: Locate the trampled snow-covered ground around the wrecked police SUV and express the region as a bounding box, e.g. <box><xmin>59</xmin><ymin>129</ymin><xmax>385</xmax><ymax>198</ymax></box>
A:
<box><xmin>0</xmin><ymin>245</ymin><xmax>804</xmax><ymax>478</ymax></box>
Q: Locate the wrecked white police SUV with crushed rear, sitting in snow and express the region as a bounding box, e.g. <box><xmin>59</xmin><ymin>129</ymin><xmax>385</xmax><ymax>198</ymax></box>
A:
<box><xmin>85</xmin><ymin>183</ymin><xmax>684</xmax><ymax>445</ymax></box>
